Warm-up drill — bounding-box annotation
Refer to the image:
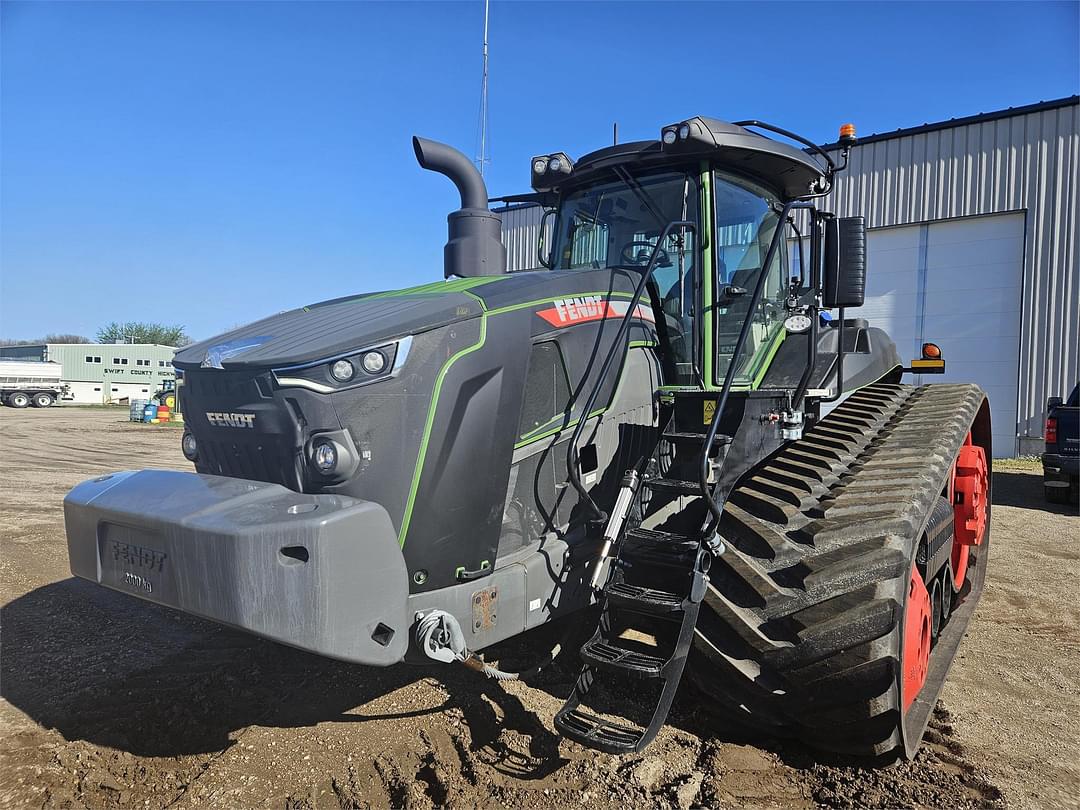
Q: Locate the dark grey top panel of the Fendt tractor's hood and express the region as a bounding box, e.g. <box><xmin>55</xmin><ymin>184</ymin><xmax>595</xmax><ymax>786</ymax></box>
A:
<box><xmin>173</xmin><ymin>269</ymin><xmax>634</xmax><ymax>370</ymax></box>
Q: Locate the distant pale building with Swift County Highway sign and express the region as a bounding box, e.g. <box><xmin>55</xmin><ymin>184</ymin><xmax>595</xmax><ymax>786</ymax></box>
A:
<box><xmin>0</xmin><ymin>343</ymin><xmax>176</xmax><ymax>405</ymax></box>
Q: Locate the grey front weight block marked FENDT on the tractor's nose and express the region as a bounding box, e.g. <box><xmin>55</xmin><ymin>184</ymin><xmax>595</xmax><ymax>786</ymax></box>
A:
<box><xmin>64</xmin><ymin>470</ymin><xmax>409</xmax><ymax>665</ymax></box>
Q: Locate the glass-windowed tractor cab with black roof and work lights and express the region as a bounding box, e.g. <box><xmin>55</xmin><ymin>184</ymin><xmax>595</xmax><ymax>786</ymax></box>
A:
<box><xmin>531</xmin><ymin>117</ymin><xmax>853</xmax><ymax>403</ymax></box>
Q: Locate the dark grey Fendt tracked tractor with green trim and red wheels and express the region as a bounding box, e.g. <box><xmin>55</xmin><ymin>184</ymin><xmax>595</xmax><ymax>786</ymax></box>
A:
<box><xmin>65</xmin><ymin>118</ymin><xmax>990</xmax><ymax>758</ymax></box>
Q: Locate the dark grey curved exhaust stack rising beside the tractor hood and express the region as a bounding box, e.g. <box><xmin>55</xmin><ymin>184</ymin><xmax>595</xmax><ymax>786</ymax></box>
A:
<box><xmin>413</xmin><ymin>136</ymin><xmax>507</xmax><ymax>279</ymax></box>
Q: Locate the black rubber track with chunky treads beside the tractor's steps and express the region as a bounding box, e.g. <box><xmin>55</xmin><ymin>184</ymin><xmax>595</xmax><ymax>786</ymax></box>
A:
<box><xmin>691</xmin><ymin>383</ymin><xmax>985</xmax><ymax>756</ymax></box>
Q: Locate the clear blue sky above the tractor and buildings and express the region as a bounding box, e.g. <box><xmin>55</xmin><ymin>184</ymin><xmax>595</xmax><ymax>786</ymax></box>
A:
<box><xmin>0</xmin><ymin>0</ymin><xmax>1080</xmax><ymax>338</ymax></box>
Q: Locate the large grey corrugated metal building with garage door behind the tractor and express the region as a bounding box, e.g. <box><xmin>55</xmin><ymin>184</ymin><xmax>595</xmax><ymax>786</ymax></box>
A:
<box><xmin>503</xmin><ymin>96</ymin><xmax>1080</xmax><ymax>456</ymax></box>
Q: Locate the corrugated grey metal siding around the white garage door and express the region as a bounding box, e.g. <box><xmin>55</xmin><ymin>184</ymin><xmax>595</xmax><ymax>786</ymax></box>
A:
<box><xmin>821</xmin><ymin>103</ymin><xmax>1080</xmax><ymax>451</ymax></box>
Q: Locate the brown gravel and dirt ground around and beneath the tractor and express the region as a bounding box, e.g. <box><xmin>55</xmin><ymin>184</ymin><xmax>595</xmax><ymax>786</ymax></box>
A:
<box><xmin>0</xmin><ymin>407</ymin><xmax>1080</xmax><ymax>810</ymax></box>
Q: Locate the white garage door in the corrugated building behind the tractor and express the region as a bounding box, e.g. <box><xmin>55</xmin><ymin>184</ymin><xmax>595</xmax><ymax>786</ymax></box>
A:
<box><xmin>858</xmin><ymin>214</ymin><xmax>1024</xmax><ymax>457</ymax></box>
